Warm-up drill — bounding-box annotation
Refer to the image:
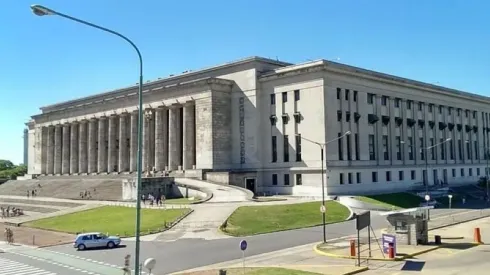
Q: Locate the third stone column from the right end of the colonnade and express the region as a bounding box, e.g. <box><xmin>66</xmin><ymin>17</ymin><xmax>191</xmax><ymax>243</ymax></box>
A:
<box><xmin>155</xmin><ymin>107</ymin><xmax>168</xmax><ymax>171</ymax></box>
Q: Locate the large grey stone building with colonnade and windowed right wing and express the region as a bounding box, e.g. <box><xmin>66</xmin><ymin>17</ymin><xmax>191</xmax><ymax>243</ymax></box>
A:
<box><xmin>27</xmin><ymin>57</ymin><xmax>490</xmax><ymax>196</ymax></box>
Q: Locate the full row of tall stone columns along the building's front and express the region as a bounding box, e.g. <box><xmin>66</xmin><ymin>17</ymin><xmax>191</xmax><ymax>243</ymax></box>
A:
<box><xmin>40</xmin><ymin>103</ymin><xmax>196</xmax><ymax>174</ymax></box>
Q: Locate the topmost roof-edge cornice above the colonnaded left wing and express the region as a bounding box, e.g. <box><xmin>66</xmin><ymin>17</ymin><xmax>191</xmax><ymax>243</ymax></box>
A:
<box><xmin>40</xmin><ymin>56</ymin><xmax>291</xmax><ymax>113</ymax></box>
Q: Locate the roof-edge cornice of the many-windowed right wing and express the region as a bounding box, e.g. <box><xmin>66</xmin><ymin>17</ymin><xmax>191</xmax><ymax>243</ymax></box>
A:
<box><xmin>259</xmin><ymin>60</ymin><xmax>490</xmax><ymax>104</ymax></box>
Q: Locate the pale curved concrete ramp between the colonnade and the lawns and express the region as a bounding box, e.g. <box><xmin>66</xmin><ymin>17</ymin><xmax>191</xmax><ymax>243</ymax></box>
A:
<box><xmin>174</xmin><ymin>178</ymin><xmax>250</xmax><ymax>202</ymax></box>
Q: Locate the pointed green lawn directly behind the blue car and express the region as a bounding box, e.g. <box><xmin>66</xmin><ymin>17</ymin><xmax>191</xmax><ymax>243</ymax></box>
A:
<box><xmin>24</xmin><ymin>206</ymin><xmax>190</xmax><ymax>237</ymax></box>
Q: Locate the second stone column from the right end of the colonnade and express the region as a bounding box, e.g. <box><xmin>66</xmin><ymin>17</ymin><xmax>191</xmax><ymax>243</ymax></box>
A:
<box><xmin>168</xmin><ymin>106</ymin><xmax>182</xmax><ymax>170</ymax></box>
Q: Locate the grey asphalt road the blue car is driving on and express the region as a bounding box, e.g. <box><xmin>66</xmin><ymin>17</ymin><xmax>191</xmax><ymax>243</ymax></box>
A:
<box><xmin>48</xmin><ymin>213</ymin><xmax>386</xmax><ymax>274</ymax></box>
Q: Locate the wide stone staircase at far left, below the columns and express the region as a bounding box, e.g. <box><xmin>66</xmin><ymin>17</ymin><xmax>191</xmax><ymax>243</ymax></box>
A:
<box><xmin>0</xmin><ymin>176</ymin><xmax>123</xmax><ymax>201</ymax></box>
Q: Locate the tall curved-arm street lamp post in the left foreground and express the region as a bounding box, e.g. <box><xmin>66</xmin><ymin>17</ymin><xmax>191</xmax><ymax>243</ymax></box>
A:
<box><xmin>31</xmin><ymin>5</ymin><xmax>143</xmax><ymax>274</ymax></box>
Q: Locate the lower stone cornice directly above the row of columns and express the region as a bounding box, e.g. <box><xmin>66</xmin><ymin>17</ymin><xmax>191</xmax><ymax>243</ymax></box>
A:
<box><xmin>31</xmin><ymin>77</ymin><xmax>235</xmax><ymax>120</ymax></box>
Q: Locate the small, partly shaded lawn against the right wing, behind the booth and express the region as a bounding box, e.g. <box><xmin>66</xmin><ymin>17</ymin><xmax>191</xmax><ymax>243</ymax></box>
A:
<box><xmin>356</xmin><ymin>193</ymin><xmax>424</xmax><ymax>210</ymax></box>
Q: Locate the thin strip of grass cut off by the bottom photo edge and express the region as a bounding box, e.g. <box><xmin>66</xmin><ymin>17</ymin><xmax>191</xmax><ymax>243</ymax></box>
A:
<box><xmin>183</xmin><ymin>267</ymin><xmax>320</xmax><ymax>275</ymax></box>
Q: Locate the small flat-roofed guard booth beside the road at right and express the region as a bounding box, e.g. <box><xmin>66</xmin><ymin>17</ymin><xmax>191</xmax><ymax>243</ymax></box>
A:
<box><xmin>381</xmin><ymin>206</ymin><xmax>433</xmax><ymax>245</ymax></box>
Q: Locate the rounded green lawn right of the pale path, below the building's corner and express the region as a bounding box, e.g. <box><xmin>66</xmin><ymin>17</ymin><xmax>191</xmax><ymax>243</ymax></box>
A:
<box><xmin>222</xmin><ymin>201</ymin><xmax>349</xmax><ymax>236</ymax></box>
